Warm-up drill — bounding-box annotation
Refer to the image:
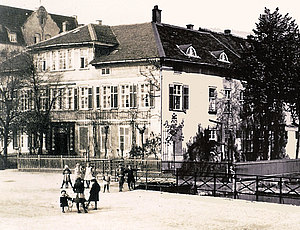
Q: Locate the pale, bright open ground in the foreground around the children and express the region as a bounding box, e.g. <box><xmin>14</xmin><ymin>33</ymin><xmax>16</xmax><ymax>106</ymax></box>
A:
<box><xmin>0</xmin><ymin>170</ymin><xmax>300</xmax><ymax>230</ymax></box>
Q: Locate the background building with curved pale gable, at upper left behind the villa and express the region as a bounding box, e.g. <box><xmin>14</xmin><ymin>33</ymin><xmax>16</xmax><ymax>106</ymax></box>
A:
<box><xmin>0</xmin><ymin>5</ymin><xmax>78</xmax><ymax>61</ymax></box>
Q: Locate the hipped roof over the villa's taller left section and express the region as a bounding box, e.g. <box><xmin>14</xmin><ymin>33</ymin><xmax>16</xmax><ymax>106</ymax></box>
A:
<box><xmin>29</xmin><ymin>24</ymin><xmax>118</xmax><ymax>49</ymax></box>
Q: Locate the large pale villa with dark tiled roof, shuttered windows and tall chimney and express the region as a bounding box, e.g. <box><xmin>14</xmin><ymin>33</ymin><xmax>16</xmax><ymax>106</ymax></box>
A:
<box><xmin>1</xmin><ymin>6</ymin><xmax>298</xmax><ymax>160</ymax></box>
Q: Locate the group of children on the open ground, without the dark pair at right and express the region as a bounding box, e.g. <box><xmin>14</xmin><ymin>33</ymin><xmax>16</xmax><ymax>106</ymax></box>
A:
<box><xmin>60</xmin><ymin>163</ymin><xmax>110</xmax><ymax>213</ymax></box>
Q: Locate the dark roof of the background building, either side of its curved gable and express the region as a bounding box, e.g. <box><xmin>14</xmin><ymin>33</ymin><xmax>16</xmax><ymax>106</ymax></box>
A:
<box><xmin>0</xmin><ymin>5</ymin><xmax>77</xmax><ymax>46</ymax></box>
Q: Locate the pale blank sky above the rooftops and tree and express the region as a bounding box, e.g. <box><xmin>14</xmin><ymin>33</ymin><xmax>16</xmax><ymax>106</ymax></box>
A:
<box><xmin>0</xmin><ymin>0</ymin><xmax>300</xmax><ymax>36</ymax></box>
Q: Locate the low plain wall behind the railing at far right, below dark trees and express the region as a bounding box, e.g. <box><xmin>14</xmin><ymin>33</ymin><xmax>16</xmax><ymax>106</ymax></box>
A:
<box><xmin>235</xmin><ymin>159</ymin><xmax>300</xmax><ymax>175</ymax></box>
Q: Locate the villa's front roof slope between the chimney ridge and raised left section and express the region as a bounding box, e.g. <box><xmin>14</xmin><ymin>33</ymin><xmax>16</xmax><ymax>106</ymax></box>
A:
<box><xmin>92</xmin><ymin>23</ymin><xmax>159</xmax><ymax>64</ymax></box>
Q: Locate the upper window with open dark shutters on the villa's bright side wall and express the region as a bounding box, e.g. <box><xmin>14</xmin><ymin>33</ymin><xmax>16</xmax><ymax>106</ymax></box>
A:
<box><xmin>169</xmin><ymin>84</ymin><xmax>189</xmax><ymax>111</ymax></box>
